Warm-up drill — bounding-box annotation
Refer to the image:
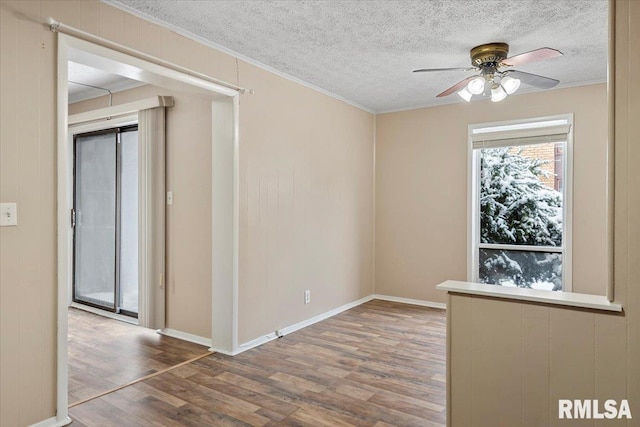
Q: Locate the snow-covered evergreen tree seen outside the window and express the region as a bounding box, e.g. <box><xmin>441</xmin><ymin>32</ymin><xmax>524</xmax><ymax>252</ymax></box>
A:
<box><xmin>480</xmin><ymin>147</ymin><xmax>562</xmax><ymax>290</ymax></box>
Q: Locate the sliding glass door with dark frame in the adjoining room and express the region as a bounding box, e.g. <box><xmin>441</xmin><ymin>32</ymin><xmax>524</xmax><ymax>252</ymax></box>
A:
<box><xmin>72</xmin><ymin>126</ymin><xmax>138</xmax><ymax>317</ymax></box>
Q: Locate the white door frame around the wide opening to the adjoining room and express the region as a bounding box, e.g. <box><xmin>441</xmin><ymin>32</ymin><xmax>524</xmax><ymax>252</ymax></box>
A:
<box><xmin>56</xmin><ymin>32</ymin><xmax>240</xmax><ymax>425</ymax></box>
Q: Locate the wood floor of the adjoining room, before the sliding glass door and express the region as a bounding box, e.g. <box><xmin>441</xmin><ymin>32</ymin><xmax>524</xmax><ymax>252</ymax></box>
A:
<box><xmin>68</xmin><ymin>308</ymin><xmax>207</xmax><ymax>404</ymax></box>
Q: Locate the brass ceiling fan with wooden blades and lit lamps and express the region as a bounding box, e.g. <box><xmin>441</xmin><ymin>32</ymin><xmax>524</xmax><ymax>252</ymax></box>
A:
<box><xmin>413</xmin><ymin>43</ymin><xmax>562</xmax><ymax>102</ymax></box>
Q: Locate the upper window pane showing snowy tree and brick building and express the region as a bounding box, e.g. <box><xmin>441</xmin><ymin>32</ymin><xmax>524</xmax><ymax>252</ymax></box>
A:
<box><xmin>480</xmin><ymin>143</ymin><xmax>564</xmax><ymax>246</ymax></box>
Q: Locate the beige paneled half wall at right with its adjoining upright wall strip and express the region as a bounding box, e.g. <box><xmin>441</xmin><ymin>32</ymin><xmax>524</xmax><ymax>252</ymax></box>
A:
<box><xmin>448</xmin><ymin>1</ymin><xmax>640</xmax><ymax>427</ymax></box>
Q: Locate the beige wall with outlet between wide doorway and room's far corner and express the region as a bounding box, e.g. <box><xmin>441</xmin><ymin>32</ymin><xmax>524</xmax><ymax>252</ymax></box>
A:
<box><xmin>239</xmin><ymin>63</ymin><xmax>374</xmax><ymax>343</ymax></box>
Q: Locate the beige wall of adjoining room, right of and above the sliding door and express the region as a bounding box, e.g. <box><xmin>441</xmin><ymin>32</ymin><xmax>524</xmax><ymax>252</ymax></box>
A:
<box><xmin>69</xmin><ymin>85</ymin><xmax>211</xmax><ymax>338</ymax></box>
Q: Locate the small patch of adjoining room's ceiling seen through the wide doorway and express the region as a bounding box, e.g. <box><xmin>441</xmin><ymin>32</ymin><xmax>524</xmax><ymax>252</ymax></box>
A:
<box><xmin>68</xmin><ymin>61</ymin><xmax>145</xmax><ymax>104</ymax></box>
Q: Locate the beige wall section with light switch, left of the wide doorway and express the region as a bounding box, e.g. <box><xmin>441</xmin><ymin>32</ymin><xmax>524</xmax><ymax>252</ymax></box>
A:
<box><xmin>0</xmin><ymin>2</ymin><xmax>57</xmax><ymax>427</ymax></box>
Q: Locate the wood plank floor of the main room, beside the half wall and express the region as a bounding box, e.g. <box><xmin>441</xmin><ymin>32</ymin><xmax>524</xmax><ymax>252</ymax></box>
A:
<box><xmin>70</xmin><ymin>300</ymin><xmax>446</xmax><ymax>427</ymax></box>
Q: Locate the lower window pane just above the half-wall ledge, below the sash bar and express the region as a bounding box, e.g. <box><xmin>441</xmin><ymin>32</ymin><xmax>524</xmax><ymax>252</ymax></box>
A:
<box><xmin>479</xmin><ymin>249</ymin><xmax>562</xmax><ymax>291</ymax></box>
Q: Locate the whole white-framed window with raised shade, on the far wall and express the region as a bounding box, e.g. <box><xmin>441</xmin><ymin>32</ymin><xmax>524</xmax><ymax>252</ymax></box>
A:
<box><xmin>469</xmin><ymin>115</ymin><xmax>573</xmax><ymax>291</ymax></box>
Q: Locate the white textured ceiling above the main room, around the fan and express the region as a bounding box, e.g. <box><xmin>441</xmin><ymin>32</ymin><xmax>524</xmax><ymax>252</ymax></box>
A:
<box><xmin>108</xmin><ymin>0</ymin><xmax>608</xmax><ymax>112</ymax></box>
